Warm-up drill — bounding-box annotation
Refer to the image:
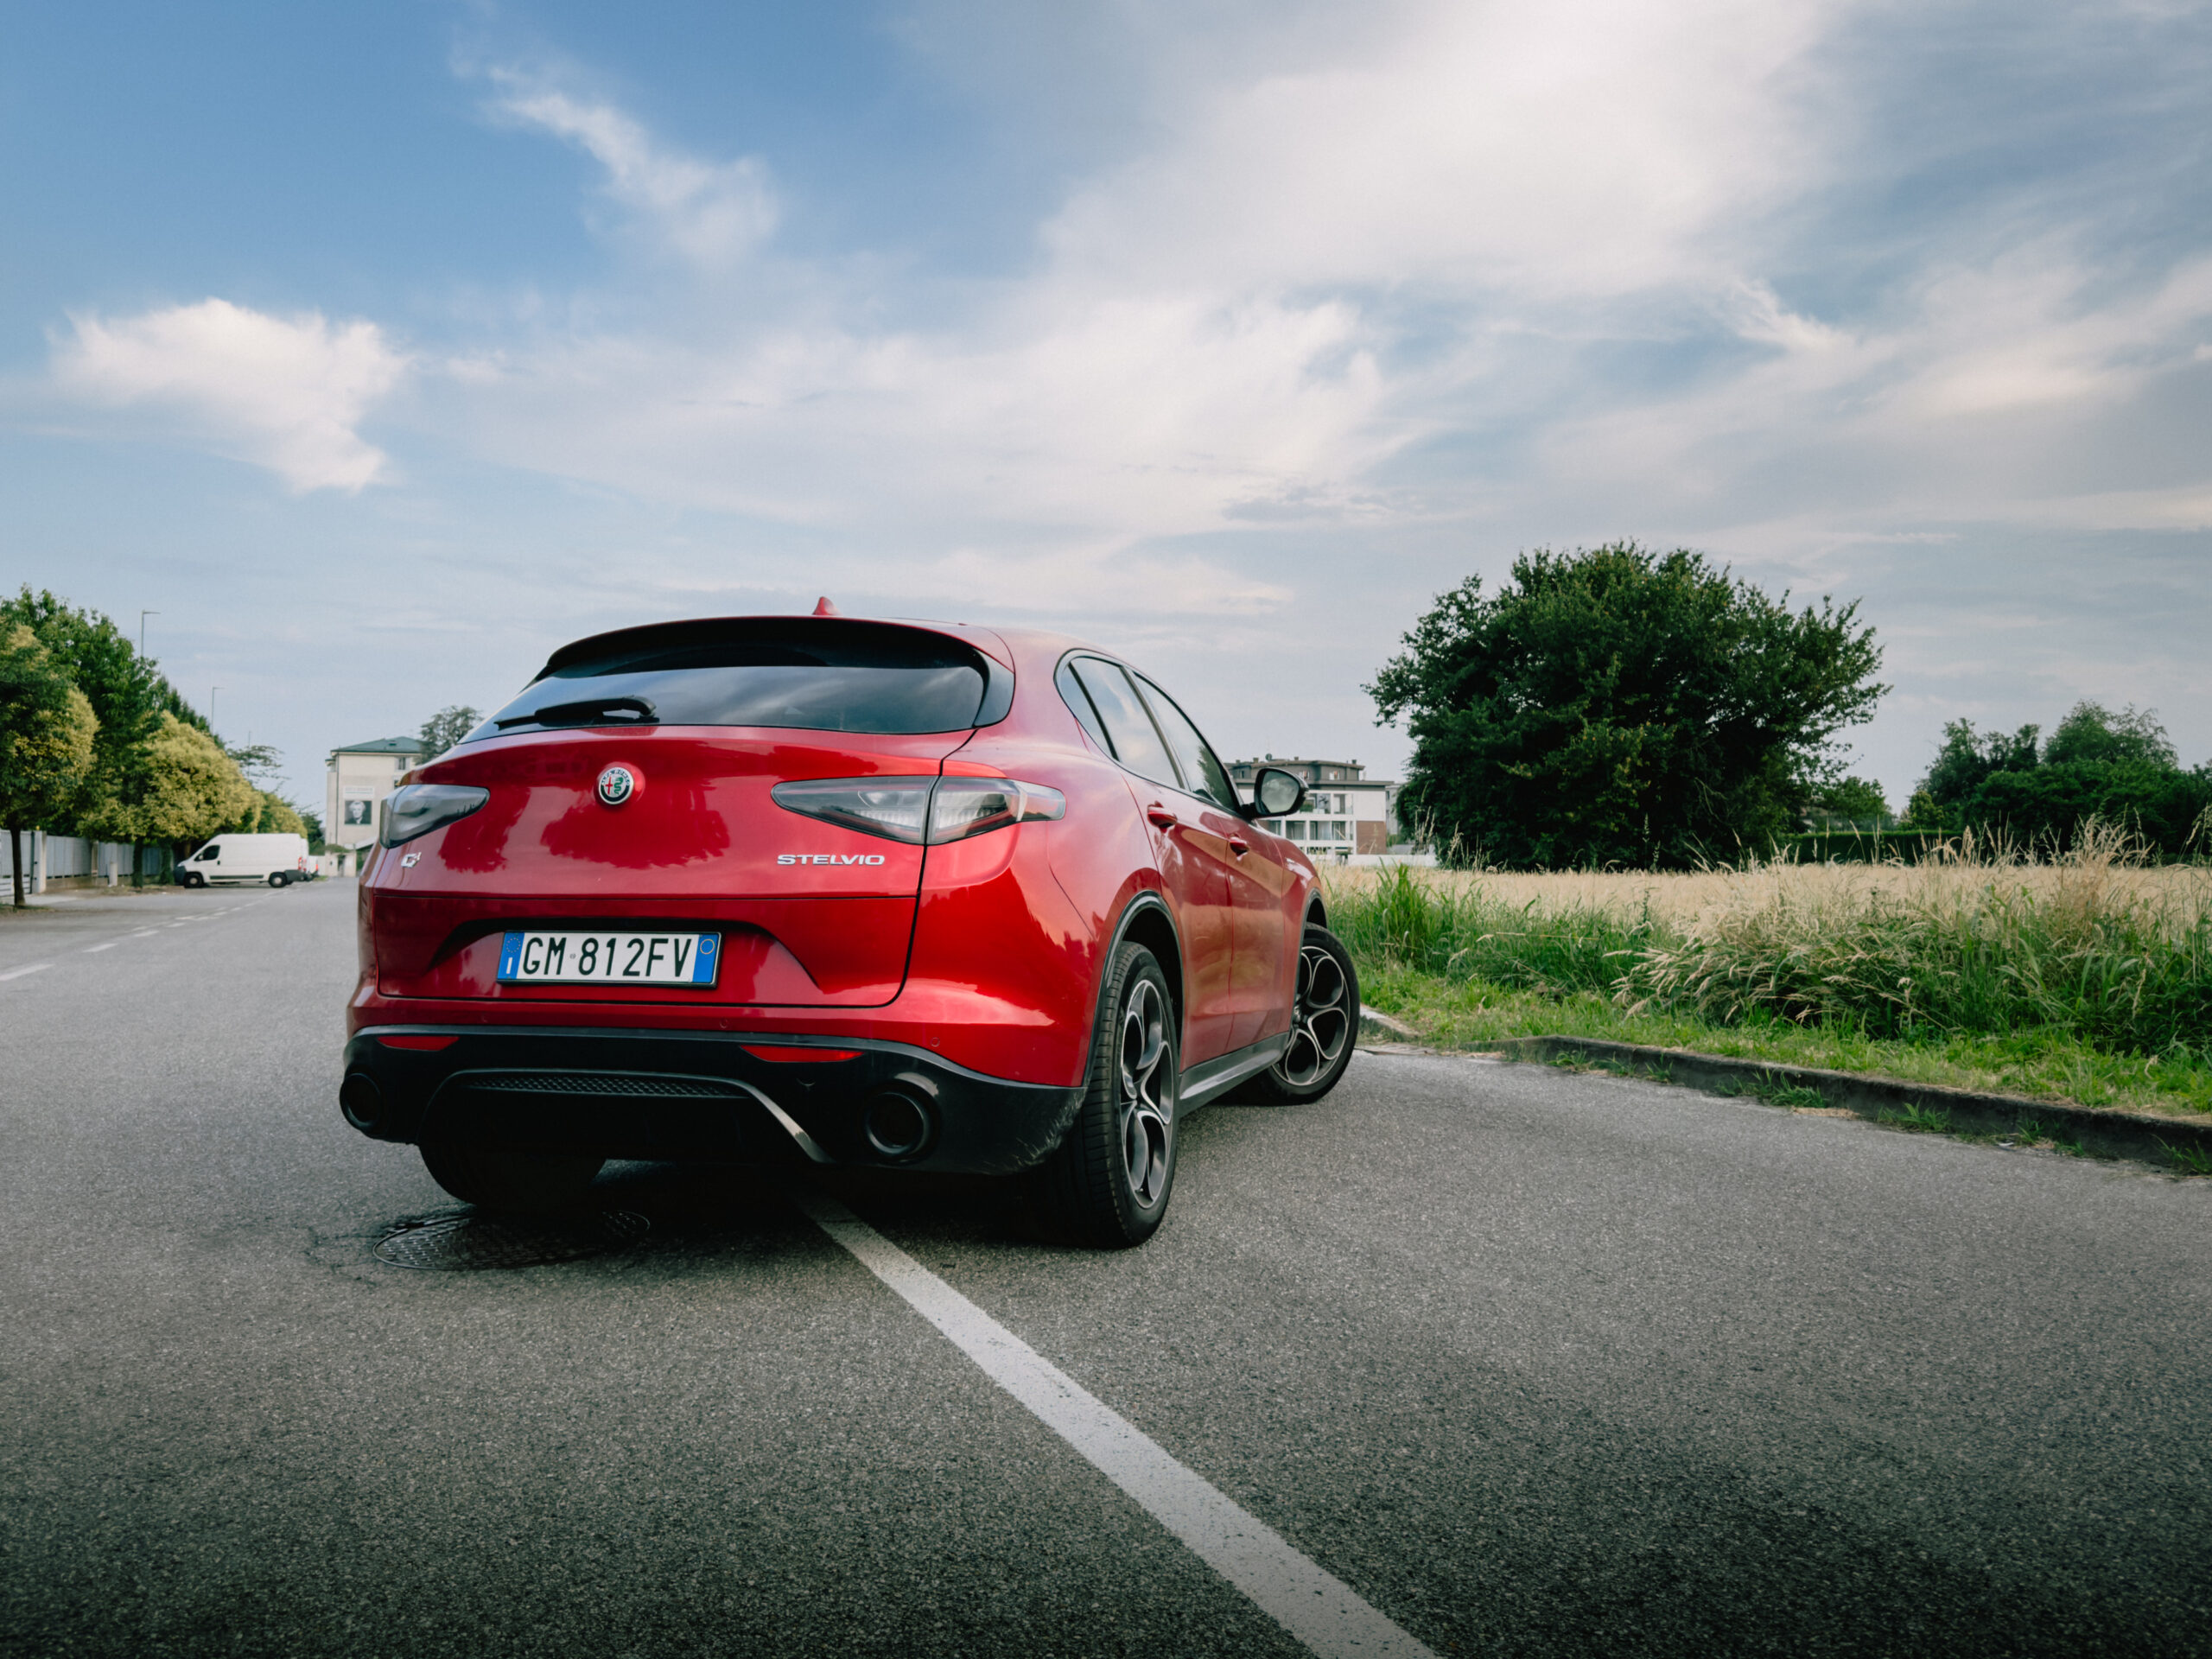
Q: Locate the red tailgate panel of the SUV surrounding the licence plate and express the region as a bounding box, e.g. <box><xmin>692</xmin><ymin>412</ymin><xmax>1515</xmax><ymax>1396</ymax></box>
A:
<box><xmin>370</xmin><ymin>726</ymin><xmax>969</xmax><ymax>1007</ymax></box>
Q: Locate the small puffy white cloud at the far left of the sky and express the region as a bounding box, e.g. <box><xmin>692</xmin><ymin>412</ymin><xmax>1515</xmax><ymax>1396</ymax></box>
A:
<box><xmin>53</xmin><ymin>299</ymin><xmax>407</xmax><ymax>491</ymax></box>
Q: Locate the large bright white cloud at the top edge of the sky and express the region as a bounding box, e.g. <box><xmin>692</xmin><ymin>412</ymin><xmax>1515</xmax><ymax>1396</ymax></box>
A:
<box><xmin>1048</xmin><ymin>0</ymin><xmax>1847</xmax><ymax>296</ymax></box>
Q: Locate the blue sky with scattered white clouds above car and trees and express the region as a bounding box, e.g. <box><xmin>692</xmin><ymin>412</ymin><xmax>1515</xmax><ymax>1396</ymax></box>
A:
<box><xmin>0</xmin><ymin>0</ymin><xmax>2212</xmax><ymax>807</ymax></box>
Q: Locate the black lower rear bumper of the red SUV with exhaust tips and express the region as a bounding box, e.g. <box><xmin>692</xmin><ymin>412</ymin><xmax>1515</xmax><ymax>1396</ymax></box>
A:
<box><xmin>340</xmin><ymin>1024</ymin><xmax>1082</xmax><ymax>1174</ymax></box>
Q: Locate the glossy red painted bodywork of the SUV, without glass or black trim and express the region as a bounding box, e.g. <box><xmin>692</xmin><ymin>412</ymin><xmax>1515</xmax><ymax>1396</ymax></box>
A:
<box><xmin>347</xmin><ymin>624</ymin><xmax>1314</xmax><ymax>1106</ymax></box>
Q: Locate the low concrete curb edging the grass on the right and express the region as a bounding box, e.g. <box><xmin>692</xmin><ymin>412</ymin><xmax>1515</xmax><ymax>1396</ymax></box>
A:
<box><xmin>1493</xmin><ymin>1038</ymin><xmax>2212</xmax><ymax>1174</ymax></box>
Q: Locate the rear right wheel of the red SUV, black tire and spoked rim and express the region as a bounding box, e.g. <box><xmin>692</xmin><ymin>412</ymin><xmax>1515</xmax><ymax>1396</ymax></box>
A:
<box><xmin>1031</xmin><ymin>944</ymin><xmax>1181</xmax><ymax>1249</ymax></box>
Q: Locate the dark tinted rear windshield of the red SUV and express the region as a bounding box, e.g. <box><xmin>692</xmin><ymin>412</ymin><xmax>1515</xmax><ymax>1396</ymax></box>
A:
<box><xmin>469</xmin><ymin>617</ymin><xmax>984</xmax><ymax>741</ymax></box>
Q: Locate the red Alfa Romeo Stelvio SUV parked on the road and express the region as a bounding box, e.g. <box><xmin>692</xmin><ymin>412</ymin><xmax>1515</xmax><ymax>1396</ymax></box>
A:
<box><xmin>340</xmin><ymin>600</ymin><xmax>1358</xmax><ymax>1248</ymax></box>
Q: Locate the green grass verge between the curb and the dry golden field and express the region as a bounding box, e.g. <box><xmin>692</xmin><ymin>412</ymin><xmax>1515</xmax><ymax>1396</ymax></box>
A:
<box><xmin>1330</xmin><ymin>869</ymin><xmax>2212</xmax><ymax>1128</ymax></box>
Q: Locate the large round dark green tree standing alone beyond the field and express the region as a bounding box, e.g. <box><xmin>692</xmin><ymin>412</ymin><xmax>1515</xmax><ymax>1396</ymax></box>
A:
<box><xmin>1367</xmin><ymin>553</ymin><xmax>1887</xmax><ymax>868</ymax></box>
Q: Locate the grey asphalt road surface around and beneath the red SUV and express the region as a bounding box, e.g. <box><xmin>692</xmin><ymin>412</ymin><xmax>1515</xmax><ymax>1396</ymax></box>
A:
<box><xmin>0</xmin><ymin>882</ymin><xmax>2212</xmax><ymax>1659</ymax></box>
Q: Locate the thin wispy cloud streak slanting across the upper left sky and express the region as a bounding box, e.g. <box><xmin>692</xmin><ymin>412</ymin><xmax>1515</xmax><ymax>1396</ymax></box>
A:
<box><xmin>486</xmin><ymin>68</ymin><xmax>777</xmax><ymax>268</ymax></box>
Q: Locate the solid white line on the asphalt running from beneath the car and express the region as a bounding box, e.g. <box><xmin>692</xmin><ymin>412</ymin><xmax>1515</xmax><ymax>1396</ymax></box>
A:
<box><xmin>794</xmin><ymin>1192</ymin><xmax>1435</xmax><ymax>1659</ymax></box>
